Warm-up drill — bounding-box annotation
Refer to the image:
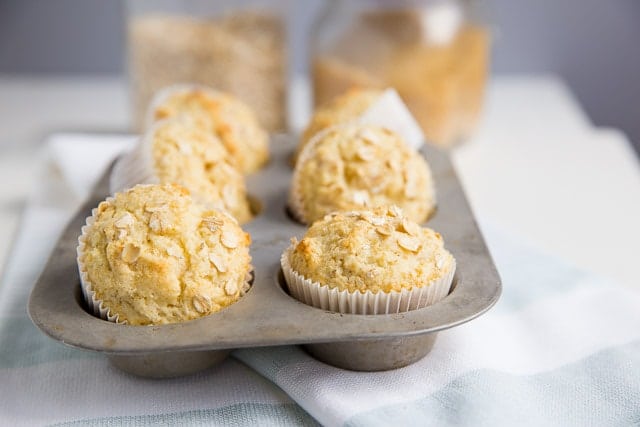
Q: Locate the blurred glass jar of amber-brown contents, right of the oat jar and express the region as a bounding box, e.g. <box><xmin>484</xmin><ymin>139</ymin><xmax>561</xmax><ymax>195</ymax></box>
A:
<box><xmin>311</xmin><ymin>0</ymin><xmax>490</xmax><ymax>147</ymax></box>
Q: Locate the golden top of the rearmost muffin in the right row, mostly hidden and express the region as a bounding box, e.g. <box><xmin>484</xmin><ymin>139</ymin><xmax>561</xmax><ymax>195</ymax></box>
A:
<box><xmin>295</xmin><ymin>88</ymin><xmax>383</xmax><ymax>163</ymax></box>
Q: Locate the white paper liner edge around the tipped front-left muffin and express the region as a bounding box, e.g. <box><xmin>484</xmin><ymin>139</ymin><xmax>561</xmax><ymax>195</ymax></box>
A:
<box><xmin>76</xmin><ymin>197</ymin><xmax>253</xmax><ymax>324</ymax></box>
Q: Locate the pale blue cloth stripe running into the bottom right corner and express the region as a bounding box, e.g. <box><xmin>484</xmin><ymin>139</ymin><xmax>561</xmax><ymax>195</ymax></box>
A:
<box><xmin>346</xmin><ymin>341</ymin><xmax>640</xmax><ymax>427</ymax></box>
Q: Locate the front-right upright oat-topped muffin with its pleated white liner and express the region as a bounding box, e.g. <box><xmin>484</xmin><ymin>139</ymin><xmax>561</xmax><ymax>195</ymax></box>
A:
<box><xmin>281</xmin><ymin>206</ymin><xmax>456</xmax><ymax>314</ymax></box>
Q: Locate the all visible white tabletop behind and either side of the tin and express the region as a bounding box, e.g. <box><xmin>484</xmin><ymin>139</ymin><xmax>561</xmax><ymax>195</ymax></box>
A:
<box><xmin>0</xmin><ymin>77</ymin><xmax>640</xmax><ymax>287</ymax></box>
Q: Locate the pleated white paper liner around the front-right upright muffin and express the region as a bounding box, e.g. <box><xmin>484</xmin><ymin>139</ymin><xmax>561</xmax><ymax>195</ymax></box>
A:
<box><xmin>280</xmin><ymin>246</ymin><xmax>456</xmax><ymax>314</ymax></box>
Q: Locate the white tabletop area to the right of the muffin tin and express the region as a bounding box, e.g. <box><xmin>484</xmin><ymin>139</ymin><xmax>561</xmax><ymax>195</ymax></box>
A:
<box><xmin>453</xmin><ymin>79</ymin><xmax>640</xmax><ymax>288</ymax></box>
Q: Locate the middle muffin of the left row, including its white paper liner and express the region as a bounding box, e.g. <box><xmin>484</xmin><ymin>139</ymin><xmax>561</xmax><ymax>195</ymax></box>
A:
<box><xmin>111</xmin><ymin>116</ymin><xmax>252</xmax><ymax>224</ymax></box>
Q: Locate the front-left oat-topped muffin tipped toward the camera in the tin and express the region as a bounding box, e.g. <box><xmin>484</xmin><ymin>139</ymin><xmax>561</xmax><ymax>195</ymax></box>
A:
<box><xmin>78</xmin><ymin>184</ymin><xmax>251</xmax><ymax>325</ymax></box>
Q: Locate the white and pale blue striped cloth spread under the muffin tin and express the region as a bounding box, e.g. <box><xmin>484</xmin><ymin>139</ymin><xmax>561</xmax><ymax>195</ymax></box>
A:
<box><xmin>0</xmin><ymin>135</ymin><xmax>640</xmax><ymax>426</ymax></box>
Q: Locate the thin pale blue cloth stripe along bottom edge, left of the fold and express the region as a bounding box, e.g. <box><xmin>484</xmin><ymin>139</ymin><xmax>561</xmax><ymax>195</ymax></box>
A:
<box><xmin>52</xmin><ymin>403</ymin><xmax>318</xmax><ymax>427</ymax></box>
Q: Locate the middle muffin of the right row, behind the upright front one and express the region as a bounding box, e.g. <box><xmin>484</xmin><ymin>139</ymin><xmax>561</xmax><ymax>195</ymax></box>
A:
<box><xmin>289</xmin><ymin>123</ymin><xmax>435</xmax><ymax>224</ymax></box>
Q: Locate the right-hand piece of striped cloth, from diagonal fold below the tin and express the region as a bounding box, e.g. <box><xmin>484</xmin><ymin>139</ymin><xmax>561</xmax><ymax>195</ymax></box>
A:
<box><xmin>234</xmin><ymin>224</ymin><xmax>640</xmax><ymax>426</ymax></box>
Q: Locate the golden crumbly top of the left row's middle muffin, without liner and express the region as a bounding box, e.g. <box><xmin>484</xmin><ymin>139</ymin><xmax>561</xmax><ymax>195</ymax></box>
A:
<box><xmin>147</xmin><ymin>116</ymin><xmax>252</xmax><ymax>224</ymax></box>
